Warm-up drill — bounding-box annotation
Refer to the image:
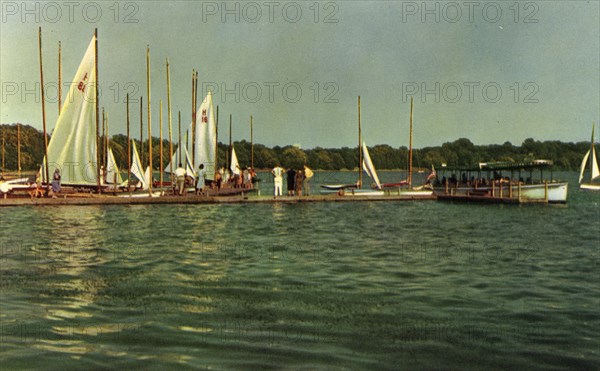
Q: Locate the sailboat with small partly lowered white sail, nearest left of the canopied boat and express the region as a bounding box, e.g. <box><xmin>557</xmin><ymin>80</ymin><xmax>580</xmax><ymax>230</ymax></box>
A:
<box><xmin>321</xmin><ymin>96</ymin><xmax>385</xmax><ymax>196</ymax></box>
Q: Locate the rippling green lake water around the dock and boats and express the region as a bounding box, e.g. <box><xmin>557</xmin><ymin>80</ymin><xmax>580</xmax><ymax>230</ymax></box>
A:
<box><xmin>0</xmin><ymin>173</ymin><xmax>600</xmax><ymax>370</ymax></box>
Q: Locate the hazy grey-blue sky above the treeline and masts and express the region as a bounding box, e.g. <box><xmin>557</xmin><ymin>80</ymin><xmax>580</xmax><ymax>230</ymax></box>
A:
<box><xmin>0</xmin><ymin>0</ymin><xmax>600</xmax><ymax>149</ymax></box>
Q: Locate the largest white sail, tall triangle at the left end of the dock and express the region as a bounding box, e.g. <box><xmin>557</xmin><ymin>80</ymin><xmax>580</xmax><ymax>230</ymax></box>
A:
<box><xmin>42</xmin><ymin>37</ymin><xmax>98</xmax><ymax>185</ymax></box>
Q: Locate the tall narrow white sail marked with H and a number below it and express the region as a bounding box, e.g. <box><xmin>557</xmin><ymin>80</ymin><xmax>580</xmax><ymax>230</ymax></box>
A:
<box><xmin>194</xmin><ymin>91</ymin><xmax>217</xmax><ymax>180</ymax></box>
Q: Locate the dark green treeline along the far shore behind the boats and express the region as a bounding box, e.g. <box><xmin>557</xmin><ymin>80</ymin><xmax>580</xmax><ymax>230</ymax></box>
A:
<box><xmin>0</xmin><ymin>124</ymin><xmax>590</xmax><ymax>171</ymax></box>
